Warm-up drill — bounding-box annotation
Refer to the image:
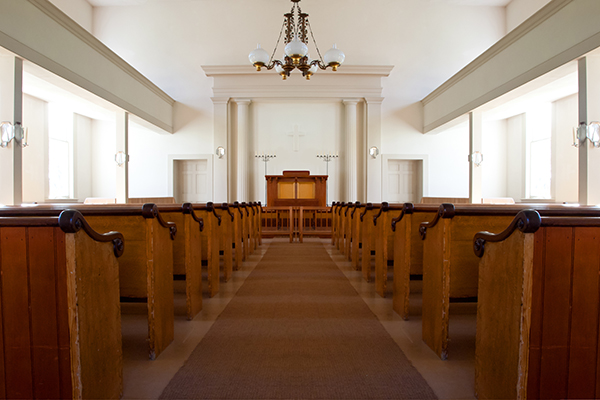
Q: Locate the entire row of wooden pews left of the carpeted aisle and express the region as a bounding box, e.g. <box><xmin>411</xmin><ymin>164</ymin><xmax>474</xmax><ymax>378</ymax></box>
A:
<box><xmin>0</xmin><ymin>202</ymin><xmax>261</xmax><ymax>399</ymax></box>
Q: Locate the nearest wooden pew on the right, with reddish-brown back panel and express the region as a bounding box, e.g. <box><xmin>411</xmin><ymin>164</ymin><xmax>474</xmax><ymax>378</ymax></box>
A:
<box><xmin>474</xmin><ymin>210</ymin><xmax>600</xmax><ymax>399</ymax></box>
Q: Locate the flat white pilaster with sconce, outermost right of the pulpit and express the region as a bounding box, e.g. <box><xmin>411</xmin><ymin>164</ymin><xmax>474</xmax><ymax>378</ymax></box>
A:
<box><xmin>363</xmin><ymin>97</ymin><xmax>387</xmax><ymax>203</ymax></box>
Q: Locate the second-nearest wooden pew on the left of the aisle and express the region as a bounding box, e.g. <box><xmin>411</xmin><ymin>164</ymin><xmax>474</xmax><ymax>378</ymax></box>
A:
<box><xmin>0</xmin><ymin>203</ymin><xmax>177</xmax><ymax>360</ymax></box>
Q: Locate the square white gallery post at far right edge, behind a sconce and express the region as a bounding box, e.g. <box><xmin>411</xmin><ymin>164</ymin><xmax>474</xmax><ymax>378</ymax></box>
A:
<box><xmin>578</xmin><ymin>56</ymin><xmax>600</xmax><ymax>205</ymax></box>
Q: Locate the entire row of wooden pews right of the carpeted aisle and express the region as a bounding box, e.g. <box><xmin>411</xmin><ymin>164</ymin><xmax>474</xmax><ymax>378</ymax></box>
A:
<box><xmin>332</xmin><ymin>202</ymin><xmax>600</xmax><ymax>399</ymax></box>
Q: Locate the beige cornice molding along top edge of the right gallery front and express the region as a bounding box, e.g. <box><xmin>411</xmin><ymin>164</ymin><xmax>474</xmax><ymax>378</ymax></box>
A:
<box><xmin>421</xmin><ymin>0</ymin><xmax>574</xmax><ymax>105</ymax></box>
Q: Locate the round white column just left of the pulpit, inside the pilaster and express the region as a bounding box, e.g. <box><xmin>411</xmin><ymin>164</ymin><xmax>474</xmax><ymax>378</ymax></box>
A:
<box><xmin>235</xmin><ymin>99</ymin><xmax>251</xmax><ymax>202</ymax></box>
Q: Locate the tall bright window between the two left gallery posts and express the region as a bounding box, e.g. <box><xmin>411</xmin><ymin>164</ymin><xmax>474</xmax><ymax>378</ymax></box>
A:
<box><xmin>48</xmin><ymin>104</ymin><xmax>73</xmax><ymax>199</ymax></box>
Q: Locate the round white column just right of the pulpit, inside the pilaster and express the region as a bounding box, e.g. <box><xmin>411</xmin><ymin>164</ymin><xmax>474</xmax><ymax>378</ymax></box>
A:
<box><xmin>343</xmin><ymin>99</ymin><xmax>358</xmax><ymax>201</ymax></box>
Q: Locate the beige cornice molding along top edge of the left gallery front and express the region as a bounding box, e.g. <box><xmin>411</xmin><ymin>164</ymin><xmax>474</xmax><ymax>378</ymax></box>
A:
<box><xmin>27</xmin><ymin>0</ymin><xmax>175</xmax><ymax>106</ymax></box>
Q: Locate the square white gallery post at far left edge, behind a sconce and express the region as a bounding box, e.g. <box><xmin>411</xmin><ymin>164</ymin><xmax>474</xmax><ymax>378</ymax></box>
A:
<box><xmin>0</xmin><ymin>56</ymin><xmax>23</xmax><ymax>205</ymax></box>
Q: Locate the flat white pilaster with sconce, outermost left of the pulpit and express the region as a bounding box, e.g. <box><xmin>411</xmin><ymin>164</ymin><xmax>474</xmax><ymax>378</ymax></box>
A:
<box><xmin>211</xmin><ymin>97</ymin><xmax>233</xmax><ymax>203</ymax></box>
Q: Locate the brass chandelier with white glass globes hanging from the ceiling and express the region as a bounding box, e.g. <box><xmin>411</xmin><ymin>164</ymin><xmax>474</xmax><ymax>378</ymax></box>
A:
<box><xmin>248</xmin><ymin>0</ymin><xmax>346</xmax><ymax>80</ymax></box>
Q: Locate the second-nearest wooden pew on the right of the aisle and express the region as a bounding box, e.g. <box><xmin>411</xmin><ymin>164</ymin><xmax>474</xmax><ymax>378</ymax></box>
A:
<box><xmin>420</xmin><ymin>204</ymin><xmax>598</xmax><ymax>360</ymax></box>
